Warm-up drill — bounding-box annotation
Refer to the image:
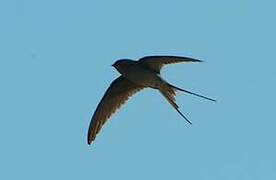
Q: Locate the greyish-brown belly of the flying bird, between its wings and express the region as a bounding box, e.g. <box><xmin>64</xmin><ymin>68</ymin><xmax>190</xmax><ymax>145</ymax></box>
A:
<box><xmin>123</xmin><ymin>69</ymin><xmax>162</xmax><ymax>88</ymax></box>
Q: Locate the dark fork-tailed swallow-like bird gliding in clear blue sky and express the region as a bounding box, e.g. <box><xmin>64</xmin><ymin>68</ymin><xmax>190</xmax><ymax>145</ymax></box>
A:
<box><xmin>87</xmin><ymin>55</ymin><xmax>216</xmax><ymax>145</ymax></box>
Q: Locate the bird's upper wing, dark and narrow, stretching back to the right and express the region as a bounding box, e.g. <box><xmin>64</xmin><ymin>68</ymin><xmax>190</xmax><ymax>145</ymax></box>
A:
<box><xmin>138</xmin><ymin>56</ymin><xmax>202</xmax><ymax>73</ymax></box>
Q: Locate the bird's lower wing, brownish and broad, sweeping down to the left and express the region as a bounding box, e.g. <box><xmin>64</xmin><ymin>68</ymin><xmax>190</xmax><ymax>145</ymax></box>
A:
<box><xmin>87</xmin><ymin>76</ymin><xmax>143</xmax><ymax>144</ymax></box>
